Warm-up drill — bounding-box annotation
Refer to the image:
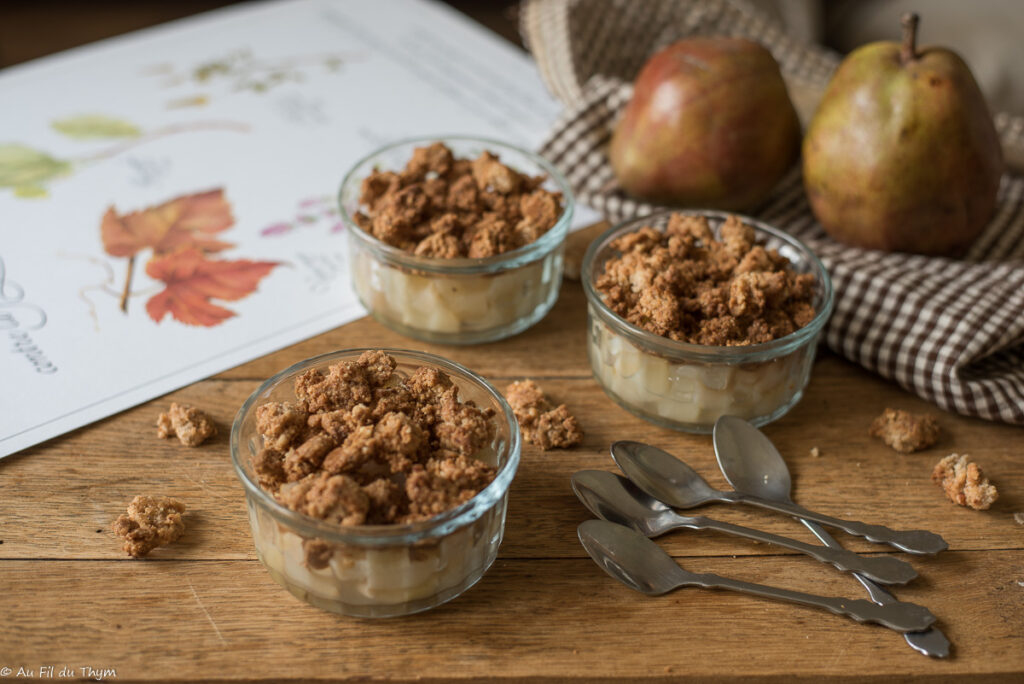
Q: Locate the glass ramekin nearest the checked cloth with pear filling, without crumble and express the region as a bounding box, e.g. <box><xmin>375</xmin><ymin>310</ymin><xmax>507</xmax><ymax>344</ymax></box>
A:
<box><xmin>583</xmin><ymin>211</ymin><xmax>833</xmax><ymax>433</ymax></box>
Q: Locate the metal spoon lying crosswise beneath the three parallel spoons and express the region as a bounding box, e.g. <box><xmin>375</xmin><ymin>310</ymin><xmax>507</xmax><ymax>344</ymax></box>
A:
<box><xmin>714</xmin><ymin>416</ymin><xmax>949</xmax><ymax>657</ymax></box>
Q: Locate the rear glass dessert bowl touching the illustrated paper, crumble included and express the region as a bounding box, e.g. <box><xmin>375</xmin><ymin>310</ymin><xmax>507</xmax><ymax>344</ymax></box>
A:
<box><xmin>339</xmin><ymin>136</ymin><xmax>573</xmax><ymax>344</ymax></box>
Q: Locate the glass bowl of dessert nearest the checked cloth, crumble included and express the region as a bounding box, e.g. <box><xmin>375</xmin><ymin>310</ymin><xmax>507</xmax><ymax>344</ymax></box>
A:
<box><xmin>583</xmin><ymin>211</ymin><xmax>833</xmax><ymax>433</ymax></box>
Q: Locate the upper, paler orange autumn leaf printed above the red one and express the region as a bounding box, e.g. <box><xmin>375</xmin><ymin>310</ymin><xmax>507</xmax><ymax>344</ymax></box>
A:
<box><xmin>99</xmin><ymin>188</ymin><xmax>234</xmax><ymax>257</ymax></box>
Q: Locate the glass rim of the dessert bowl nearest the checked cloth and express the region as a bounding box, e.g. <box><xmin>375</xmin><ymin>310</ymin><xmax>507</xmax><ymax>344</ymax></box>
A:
<box><xmin>582</xmin><ymin>209</ymin><xmax>835</xmax><ymax>364</ymax></box>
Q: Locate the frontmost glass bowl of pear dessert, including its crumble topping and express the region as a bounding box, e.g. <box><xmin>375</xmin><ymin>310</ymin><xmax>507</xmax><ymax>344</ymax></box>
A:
<box><xmin>231</xmin><ymin>349</ymin><xmax>520</xmax><ymax>617</ymax></box>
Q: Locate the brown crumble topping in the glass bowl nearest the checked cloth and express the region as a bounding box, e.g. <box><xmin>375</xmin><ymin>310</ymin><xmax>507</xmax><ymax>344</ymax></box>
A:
<box><xmin>595</xmin><ymin>214</ymin><xmax>815</xmax><ymax>346</ymax></box>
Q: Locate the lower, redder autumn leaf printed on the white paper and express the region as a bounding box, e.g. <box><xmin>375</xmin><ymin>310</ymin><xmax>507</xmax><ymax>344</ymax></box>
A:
<box><xmin>145</xmin><ymin>247</ymin><xmax>279</xmax><ymax>327</ymax></box>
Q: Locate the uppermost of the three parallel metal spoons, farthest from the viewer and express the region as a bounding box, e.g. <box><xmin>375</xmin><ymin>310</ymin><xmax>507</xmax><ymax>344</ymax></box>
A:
<box><xmin>611</xmin><ymin>441</ymin><xmax>949</xmax><ymax>553</ymax></box>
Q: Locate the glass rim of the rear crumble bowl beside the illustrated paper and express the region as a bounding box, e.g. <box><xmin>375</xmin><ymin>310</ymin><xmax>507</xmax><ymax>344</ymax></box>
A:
<box><xmin>337</xmin><ymin>135</ymin><xmax>575</xmax><ymax>274</ymax></box>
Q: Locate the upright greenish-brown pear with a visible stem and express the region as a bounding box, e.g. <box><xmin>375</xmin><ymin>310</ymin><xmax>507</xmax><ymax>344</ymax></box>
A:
<box><xmin>803</xmin><ymin>14</ymin><xmax>1002</xmax><ymax>255</ymax></box>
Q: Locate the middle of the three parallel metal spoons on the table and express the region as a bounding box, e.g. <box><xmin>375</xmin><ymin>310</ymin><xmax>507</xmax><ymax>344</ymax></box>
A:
<box><xmin>572</xmin><ymin>470</ymin><xmax>918</xmax><ymax>585</ymax></box>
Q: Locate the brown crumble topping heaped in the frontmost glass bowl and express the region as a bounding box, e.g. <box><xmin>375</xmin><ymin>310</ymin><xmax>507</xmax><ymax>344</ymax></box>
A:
<box><xmin>253</xmin><ymin>351</ymin><xmax>496</xmax><ymax>525</ymax></box>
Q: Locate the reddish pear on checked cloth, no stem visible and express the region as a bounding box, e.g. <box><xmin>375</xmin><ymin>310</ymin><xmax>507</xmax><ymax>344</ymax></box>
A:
<box><xmin>608</xmin><ymin>38</ymin><xmax>800</xmax><ymax>210</ymax></box>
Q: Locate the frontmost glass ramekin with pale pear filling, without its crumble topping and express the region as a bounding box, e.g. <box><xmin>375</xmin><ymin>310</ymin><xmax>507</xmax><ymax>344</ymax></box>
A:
<box><xmin>231</xmin><ymin>349</ymin><xmax>520</xmax><ymax>617</ymax></box>
